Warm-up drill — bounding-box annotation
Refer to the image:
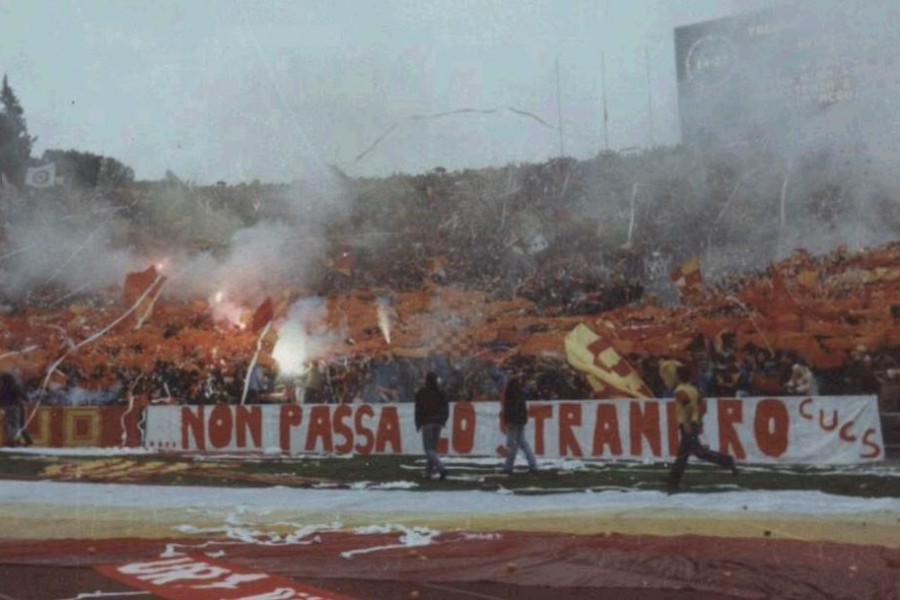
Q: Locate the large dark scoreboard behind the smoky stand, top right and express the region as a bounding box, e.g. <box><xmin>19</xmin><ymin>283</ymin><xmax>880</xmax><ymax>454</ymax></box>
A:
<box><xmin>675</xmin><ymin>2</ymin><xmax>900</xmax><ymax>146</ymax></box>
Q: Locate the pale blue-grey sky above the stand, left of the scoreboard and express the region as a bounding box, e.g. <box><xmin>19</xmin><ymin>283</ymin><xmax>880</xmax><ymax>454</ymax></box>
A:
<box><xmin>0</xmin><ymin>0</ymin><xmax>776</xmax><ymax>184</ymax></box>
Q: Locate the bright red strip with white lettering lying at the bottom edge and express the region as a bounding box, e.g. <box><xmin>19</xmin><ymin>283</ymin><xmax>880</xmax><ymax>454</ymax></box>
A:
<box><xmin>95</xmin><ymin>555</ymin><xmax>351</xmax><ymax>600</ymax></box>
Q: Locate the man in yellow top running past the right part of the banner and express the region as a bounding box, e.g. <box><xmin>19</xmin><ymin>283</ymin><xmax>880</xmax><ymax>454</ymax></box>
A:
<box><xmin>669</xmin><ymin>365</ymin><xmax>738</xmax><ymax>494</ymax></box>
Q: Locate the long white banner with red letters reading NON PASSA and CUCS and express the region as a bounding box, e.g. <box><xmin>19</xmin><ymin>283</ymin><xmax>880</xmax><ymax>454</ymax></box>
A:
<box><xmin>145</xmin><ymin>396</ymin><xmax>884</xmax><ymax>465</ymax></box>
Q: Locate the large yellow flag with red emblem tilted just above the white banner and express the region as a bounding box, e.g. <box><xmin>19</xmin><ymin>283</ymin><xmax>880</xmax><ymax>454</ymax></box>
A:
<box><xmin>566</xmin><ymin>323</ymin><xmax>653</xmax><ymax>398</ymax></box>
